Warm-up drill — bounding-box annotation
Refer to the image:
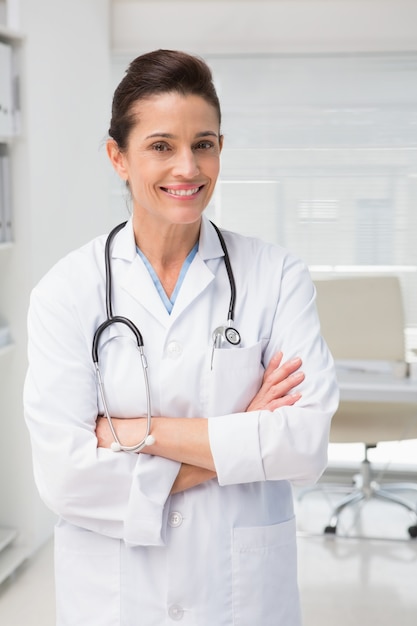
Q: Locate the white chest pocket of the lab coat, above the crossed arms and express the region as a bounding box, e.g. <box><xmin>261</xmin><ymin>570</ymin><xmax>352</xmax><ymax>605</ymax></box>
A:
<box><xmin>207</xmin><ymin>341</ymin><xmax>264</xmax><ymax>417</ymax></box>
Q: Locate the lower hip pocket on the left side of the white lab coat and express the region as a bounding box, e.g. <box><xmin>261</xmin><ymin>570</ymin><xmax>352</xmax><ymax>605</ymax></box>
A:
<box><xmin>55</xmin><ymin>520</ymin><xmax>120</xmax><ymax>626</ymax></box>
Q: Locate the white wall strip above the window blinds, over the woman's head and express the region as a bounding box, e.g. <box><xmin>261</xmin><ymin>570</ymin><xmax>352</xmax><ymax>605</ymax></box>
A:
<box><xmin>112</xmin><ymin>0</ymin><xmax>417</xmax><ymax>55</ymax></box>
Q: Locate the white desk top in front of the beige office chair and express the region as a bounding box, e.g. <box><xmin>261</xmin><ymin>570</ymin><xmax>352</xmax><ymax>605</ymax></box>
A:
<box><xmin>336</xmin><ymin>363</ymin><xmax>417</xmax><ymax>410</ymax></box>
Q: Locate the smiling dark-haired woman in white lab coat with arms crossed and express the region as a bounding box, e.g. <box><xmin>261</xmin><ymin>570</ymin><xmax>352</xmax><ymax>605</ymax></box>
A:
<box><xmin>25</xmin><ymin>50</ymin><xmax>338</xmax><ymax>626</ymax></box>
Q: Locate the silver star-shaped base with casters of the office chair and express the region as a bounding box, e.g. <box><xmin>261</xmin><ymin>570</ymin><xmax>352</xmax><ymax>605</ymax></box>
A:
<box><xmin>300</xmin><ymin>446</ymin><xmax>417</xmax><ymax>539</ymax></box>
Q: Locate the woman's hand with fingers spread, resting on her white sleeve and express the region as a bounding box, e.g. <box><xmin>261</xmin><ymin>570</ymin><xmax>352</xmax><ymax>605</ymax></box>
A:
<box><xmin>246</xmin><ymin>352</ymin><xmax>305</xmax><ymax>411</ymax></box>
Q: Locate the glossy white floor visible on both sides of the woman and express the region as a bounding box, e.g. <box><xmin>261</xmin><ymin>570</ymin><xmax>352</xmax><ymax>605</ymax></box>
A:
<box><xmin>0</xmin><ymin>493</ymin><xmax>417</xmax><ymax>626</ymax></box>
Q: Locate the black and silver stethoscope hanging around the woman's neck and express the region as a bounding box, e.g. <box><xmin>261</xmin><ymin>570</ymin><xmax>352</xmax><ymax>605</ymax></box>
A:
<box><xmin>92</xmin><ymin>222</ymin><xmax>240</xmax><ymax>452</ymax></box>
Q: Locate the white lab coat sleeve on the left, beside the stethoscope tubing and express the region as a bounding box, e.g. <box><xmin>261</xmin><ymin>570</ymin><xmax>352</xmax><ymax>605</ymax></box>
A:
<box><xmin>24</xmin><ymin>271</ymin><xmax>179</xmax><ymax>545</ymax></box>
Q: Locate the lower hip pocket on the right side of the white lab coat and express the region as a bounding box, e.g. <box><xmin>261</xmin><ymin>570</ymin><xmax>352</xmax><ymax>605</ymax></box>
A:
<box><xmin>232</xmin><ymin>518</ymin><xmax>301</xmax><ymax>626</ymax></box>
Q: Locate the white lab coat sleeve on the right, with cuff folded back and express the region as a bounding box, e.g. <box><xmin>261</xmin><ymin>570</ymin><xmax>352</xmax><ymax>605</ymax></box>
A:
<box><xmin>209</xmin><ymin>256</ymin><xmax>339</xmax><ymax>485</ymax></box>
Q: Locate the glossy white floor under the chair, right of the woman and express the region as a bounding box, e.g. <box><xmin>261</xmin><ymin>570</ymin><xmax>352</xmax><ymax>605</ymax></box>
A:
<box><xmin>296</xmin><ymin>482</ymin><xmax>417</xmax><ymax>626</ymax></box>
